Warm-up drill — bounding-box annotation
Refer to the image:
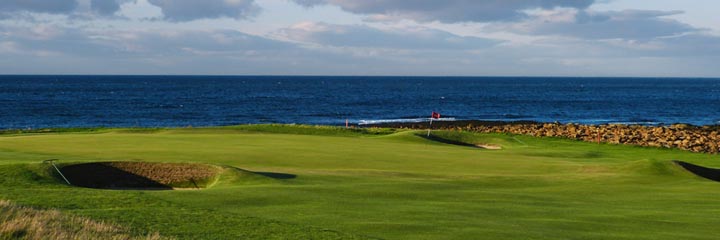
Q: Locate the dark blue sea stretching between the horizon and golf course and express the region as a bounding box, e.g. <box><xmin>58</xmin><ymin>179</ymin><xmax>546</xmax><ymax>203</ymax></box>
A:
<box><xmin>0</xmin><ymin>76</ymin><xmax>720</xmax><ymax>129</ymax></box>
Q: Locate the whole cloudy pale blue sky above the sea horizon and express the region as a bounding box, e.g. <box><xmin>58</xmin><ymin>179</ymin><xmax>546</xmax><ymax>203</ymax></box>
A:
<box><xmin>0</xmin><ymin>0</ymin><xmax>720</xmax><ymax>77</ymax></box>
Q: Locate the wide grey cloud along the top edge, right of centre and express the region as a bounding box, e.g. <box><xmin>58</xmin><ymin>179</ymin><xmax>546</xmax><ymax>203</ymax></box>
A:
<box><xmin>293</xmin><ymin>0</ymin><xmax>594</xmax><ymax>23</ymax></box>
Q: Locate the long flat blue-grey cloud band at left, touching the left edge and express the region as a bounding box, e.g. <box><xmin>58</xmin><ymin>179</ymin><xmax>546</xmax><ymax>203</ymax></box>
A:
<box><xmin>0</xmin><ymin>21</ymin><xmax>294</xmax><ymax>61</ymax></box>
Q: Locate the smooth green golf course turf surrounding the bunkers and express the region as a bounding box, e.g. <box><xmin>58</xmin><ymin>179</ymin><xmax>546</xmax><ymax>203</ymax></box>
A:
<box><xmin>0</xmin><ymin>125</ymin><xmax>720</xmax><ymax>239</ymax></box>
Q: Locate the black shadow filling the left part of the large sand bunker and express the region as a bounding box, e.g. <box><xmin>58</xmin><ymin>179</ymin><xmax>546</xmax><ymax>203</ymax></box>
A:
<box><xmin>61</xmin><ymin>163</ymin><xmax>173</xmax><ymax>190</ymax></box>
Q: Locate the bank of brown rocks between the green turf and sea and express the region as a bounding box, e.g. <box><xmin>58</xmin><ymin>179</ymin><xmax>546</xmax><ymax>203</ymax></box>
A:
<box><xmin>372</xmin><ymin>121</ymin><xmax>720</xmax><ymax>153</ymax></box>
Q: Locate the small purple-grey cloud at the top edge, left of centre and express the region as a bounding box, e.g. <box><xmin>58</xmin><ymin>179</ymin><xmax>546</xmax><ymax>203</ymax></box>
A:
<box><xmin>149</xmin><ymin>0</ymin><xmax>260</xmax><ymax>22</ymax></box>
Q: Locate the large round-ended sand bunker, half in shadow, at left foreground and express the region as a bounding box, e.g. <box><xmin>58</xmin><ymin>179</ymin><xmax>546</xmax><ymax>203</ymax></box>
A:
<box><xmin>61</xmin><ymin>162</ymin><xmax>221</xmax><ymax>190</ymax></box>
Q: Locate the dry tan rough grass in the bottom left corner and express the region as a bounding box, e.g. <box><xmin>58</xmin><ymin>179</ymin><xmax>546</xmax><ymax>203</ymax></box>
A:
<box><xmin>0</xmin><ymin>200</ymin><xmax>168</xmax><ymax>240</ymax></box>
